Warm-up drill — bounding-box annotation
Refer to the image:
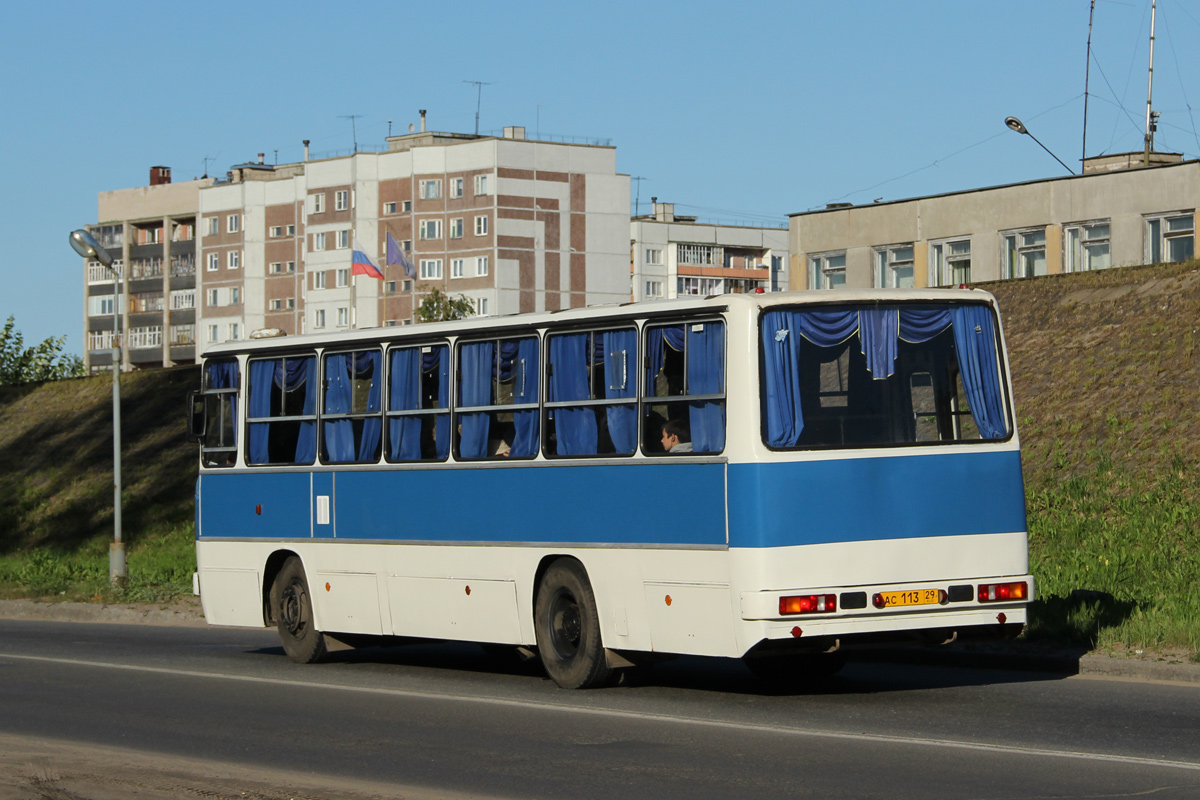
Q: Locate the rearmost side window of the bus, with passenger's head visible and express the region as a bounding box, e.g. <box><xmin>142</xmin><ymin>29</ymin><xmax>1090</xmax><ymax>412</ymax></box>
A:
<box><xmin>642</xmin><ymin>321</ymin><xmax>725</xmax><ymax>456</ymax></box>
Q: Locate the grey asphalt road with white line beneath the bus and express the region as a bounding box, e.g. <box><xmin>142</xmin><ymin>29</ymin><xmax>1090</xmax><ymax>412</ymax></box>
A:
<box><xmin>0</xmin><ymin>620</ymin><xmax>1200</xmax><ymax>800</ymax></box>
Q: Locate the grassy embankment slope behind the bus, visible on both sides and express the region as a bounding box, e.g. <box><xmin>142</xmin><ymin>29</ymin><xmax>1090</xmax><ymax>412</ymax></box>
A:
<box><xmin>0</xmin><ymin>263</ymin><xmax>1200</xmax><ymax>652</ymax></box>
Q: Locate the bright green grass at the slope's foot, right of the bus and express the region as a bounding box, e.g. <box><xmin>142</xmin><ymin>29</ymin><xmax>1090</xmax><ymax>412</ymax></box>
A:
<box><xmin>1027</xmin><ymin>453</ymin><xmax>1200</xmax><ymax>660</ymax></box>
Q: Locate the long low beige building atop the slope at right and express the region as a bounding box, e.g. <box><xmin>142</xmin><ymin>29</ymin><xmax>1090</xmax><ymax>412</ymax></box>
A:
<box><xmin>788</xmin><ymin>152</ymin><xmax>1200</xmax><ymax>289</ymax></box>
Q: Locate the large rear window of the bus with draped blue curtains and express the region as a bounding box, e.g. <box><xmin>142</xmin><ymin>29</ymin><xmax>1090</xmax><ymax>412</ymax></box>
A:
<box><xmin>762</xmin><ymin>305</ymin><xmax>1009</xmax><ymax>449</ymax></box>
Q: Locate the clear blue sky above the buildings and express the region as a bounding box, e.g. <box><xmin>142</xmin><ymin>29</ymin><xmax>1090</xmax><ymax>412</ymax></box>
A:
<box><xmin>0</xmin><ymin>0</ymin><xmax>1200</xmax><ymax>353</ymax></box>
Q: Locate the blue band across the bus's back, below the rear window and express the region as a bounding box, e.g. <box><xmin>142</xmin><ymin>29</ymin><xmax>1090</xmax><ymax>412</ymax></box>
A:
<box><xmin>730</xmin><ymin>451</ymin><xmax>1026</xmax><ymax>547</ymax></box>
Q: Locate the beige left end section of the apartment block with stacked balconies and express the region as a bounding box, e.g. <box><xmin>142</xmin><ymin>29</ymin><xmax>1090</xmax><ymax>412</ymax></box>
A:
<box><xmin>83</xmin><ymin>167</ymin><xmax>212</xmax><ymax>369</ymax></box>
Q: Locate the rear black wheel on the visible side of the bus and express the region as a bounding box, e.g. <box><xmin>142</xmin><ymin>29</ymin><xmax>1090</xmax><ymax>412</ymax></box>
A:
<box><xmin>533</xmin><ymin>559</ymin><xmax>612</xmax><ymax>688</ymax></box>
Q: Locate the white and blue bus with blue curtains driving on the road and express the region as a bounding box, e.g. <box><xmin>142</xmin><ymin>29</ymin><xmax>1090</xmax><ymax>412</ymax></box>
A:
<box><xmin>191</xmin><ymin>290</ymin><xmax>1033</xmax><ymax>687</ymax></box>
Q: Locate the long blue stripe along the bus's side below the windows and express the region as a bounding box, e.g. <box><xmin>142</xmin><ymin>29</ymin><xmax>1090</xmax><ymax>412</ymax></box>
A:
<box><xmin>199</xmin><ymin>462</ymin><xmax>725</xmax><ymax>547</ymax></box>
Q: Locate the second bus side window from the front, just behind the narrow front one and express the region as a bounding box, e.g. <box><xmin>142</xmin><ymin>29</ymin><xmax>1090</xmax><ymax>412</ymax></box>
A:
<box><xmin>246</xmin><ymin>355</ymin><xmax>317</xmax><ymax>464</ymax></box>
